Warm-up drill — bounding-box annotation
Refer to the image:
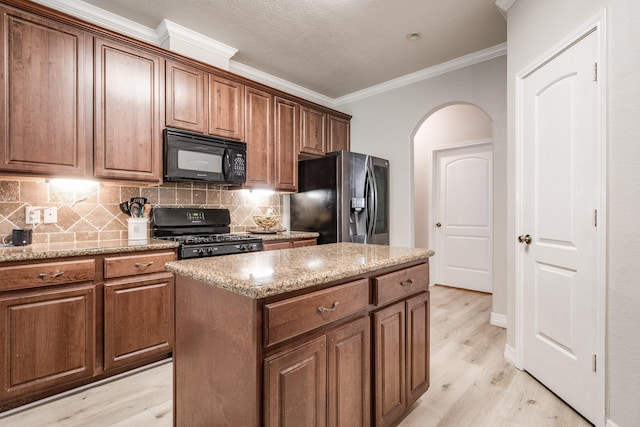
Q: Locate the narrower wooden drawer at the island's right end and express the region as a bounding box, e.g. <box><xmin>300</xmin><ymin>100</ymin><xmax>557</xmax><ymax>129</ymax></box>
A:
<box><xmin>373</xmin><ymin>264</ymin><xmax>429</xmax><ymax>305</ymax></box>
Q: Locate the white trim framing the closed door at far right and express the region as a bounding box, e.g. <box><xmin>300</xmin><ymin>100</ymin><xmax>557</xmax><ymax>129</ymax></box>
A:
<box><xmin>505</xmin><ymin>10</ymin><xmax>607</xmax><ymax>426</ymax></box>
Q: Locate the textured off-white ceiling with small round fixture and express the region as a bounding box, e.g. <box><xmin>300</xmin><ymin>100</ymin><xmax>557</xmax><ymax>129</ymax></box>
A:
<box><xmin>79</xmin><ymin>0</ymin><xmax>506</xmax><ymax>98</ymax></box>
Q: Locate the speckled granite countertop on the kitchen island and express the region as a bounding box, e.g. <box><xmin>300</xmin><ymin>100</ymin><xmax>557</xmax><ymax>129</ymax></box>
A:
<box><xmin>166</xmin><ymin>243</ymin><xmax>434</xmax><ymax>299</ymax></box>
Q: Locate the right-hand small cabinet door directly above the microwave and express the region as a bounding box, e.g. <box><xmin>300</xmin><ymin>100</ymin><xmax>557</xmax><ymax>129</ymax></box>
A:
<box><xmin>209</xmin><ymin>74</ymin><xmax>248</xmax><ymax>140</ymax></box>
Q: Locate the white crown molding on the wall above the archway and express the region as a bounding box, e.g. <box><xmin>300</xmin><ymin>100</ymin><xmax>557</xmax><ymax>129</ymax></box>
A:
<box><xmin>333</xmin><ymin>43</ymin><xmax>507</xmax><ymax>106</ymax></box>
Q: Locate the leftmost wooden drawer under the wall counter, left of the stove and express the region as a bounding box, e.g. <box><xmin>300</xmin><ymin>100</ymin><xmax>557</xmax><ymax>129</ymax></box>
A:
<box><xmin>0</xmin><ymin>259</ymin><xmax>95</xmax><ymax>291</ymax></box>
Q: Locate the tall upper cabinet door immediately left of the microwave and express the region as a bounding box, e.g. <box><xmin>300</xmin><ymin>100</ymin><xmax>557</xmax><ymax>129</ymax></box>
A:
<box><xmin>94</xmin><ymin>39</ymin><xmax>164</xmax><ymax>184</ymax></box>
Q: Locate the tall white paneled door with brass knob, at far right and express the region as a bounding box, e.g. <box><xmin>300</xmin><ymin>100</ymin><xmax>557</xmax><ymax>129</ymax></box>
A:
<box><xmin>519</xmin><ymin>33</ymin><xmax>598</xmax><ymax>422</ymax></box>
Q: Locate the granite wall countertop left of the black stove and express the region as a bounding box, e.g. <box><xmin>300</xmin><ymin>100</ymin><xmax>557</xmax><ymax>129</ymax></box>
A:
<box><xmin>0</xmin><ymin>239</ymin><xmax>178</xmax><ymax>263</ymax></box>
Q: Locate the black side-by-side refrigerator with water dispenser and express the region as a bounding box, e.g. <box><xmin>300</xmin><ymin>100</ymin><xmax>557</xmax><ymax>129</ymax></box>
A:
<box><xmin>290</xmin><ymin>151</ymin><xmax>389</xmax><ymax>245</ymax></box>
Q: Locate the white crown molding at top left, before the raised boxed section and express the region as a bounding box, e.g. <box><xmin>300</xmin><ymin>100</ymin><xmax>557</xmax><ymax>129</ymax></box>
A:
<box><xmin>32</xmin><ymin>0</ymin><xmax>160</xmax><ymax>45</ymax></box>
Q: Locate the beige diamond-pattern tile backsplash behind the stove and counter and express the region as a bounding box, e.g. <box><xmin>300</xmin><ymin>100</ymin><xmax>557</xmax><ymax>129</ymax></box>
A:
<box><xmin>0</xmin><ymin>179</ymin><xmax>282</xmax><ymax>243</ymax></box>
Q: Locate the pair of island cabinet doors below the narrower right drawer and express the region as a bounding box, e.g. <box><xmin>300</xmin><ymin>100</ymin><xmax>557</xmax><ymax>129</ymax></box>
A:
<box><xmin>373</xmin><ymin>292</ymin><xmax>429</xmax><ymax>426</ymax></box>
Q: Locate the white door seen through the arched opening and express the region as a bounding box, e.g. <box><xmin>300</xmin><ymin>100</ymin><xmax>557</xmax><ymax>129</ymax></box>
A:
<box><xmin>432</xmin><ymin>144</ymin><xmax>493</xmax><ymax>292</ymax></box>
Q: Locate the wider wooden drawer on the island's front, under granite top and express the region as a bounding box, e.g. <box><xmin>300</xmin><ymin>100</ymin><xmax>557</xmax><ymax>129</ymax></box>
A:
<box><xmin>265</xmin><ymin>279</ymin><xmax>369</xmax><ymax>346</ymax></box>
